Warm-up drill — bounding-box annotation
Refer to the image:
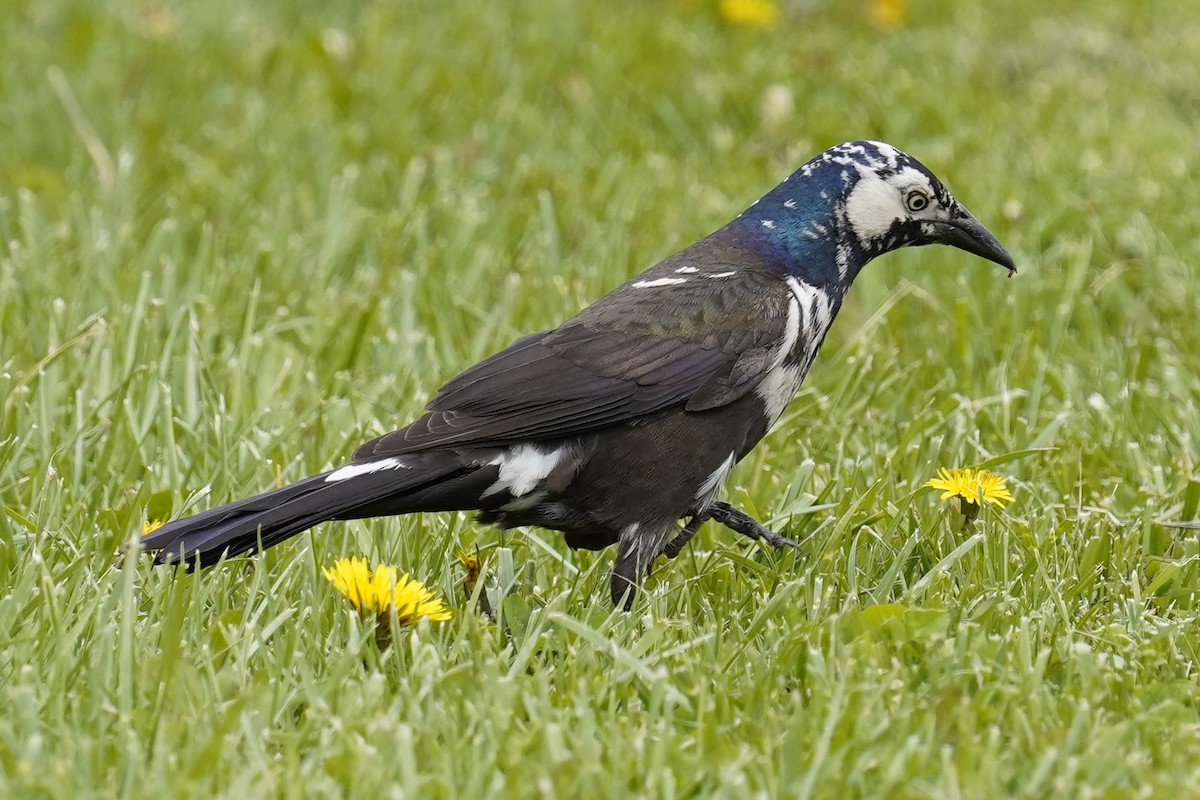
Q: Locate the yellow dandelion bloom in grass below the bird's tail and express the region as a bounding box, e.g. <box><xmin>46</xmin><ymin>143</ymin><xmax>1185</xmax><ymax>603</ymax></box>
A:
<box><xmin>322</xmin><ymin>557</ymin><xmax>450</xmax><ymax>625</ymax></box>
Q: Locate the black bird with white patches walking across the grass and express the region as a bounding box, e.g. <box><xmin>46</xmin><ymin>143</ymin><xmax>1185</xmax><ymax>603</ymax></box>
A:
<box><xmin>142</xmin><ymin>140</ymin><xmax>1016</xmax><ymax>610</ymax></box>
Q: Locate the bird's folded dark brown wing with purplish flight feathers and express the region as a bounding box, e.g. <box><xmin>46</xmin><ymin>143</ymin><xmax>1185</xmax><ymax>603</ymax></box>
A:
<box><xmin>354</xmin><ymin>270</ymin><xmax>799</xmax><ymax>461</ymax></box>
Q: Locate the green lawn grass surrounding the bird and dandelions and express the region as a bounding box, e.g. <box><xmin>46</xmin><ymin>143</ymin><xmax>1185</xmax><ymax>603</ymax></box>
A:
<box><xmin>0</xmin><ymin>0</ymin><xmax>1200</xmax><ymax>798</ymax></box>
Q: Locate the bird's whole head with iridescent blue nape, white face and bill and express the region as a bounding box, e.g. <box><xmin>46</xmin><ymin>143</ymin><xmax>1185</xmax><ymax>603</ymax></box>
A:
<box><xmin>737</xmin><ymin>142</ymin><xmax>1016</xmax><ymax>284</ymax></box>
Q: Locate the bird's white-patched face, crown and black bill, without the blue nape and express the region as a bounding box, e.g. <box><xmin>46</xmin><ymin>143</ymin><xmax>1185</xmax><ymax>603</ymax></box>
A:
<box><xmin>823</xmin><ymin>142</ymin><xmax>1016</xmax><ymax>275</ymax></box>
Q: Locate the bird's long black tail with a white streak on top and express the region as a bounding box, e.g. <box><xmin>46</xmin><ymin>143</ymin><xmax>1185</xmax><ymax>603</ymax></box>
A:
<box><xmin>142</xmin><ymin>452</ymin><xmax>497</xmax><ymax>567</ymax></box>
